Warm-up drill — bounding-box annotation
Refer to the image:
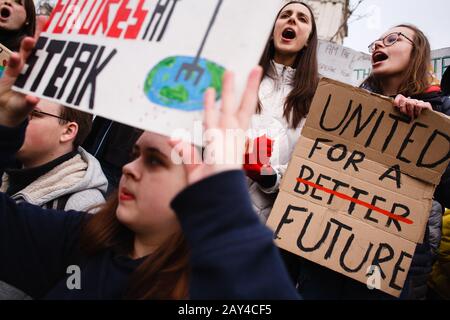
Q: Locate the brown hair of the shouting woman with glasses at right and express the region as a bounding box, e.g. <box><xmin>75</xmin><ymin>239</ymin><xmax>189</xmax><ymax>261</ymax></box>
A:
<box><xmin>361</xmin><ymin>24</ymin><xmax>432</xmax><ymax>97</ymax></box>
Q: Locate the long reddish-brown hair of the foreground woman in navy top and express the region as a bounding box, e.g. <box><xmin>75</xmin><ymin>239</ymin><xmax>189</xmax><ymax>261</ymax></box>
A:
<box><xmin>80</xmin><ymin>193</ymin><xmax>189</xmax><ymax>299</ymax></box>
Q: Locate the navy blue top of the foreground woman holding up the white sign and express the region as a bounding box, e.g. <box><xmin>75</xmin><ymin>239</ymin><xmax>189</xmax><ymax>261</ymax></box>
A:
<box><xmin>0</xmin><ymin>123</ymin><xmax>298</xmax><ymax>299</ymax></box>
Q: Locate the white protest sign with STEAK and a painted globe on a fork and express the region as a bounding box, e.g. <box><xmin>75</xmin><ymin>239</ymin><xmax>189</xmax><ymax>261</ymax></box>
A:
<box><xmin>15</xmin><ymin>0</ymin><xmax>281</xmax><ymax>141</ymax></box>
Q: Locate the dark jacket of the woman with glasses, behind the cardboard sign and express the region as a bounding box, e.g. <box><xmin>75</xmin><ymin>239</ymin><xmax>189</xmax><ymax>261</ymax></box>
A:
<box><xmin>282</xmin><ymin>86</ymin><xmax>450</xmax><ymax>300</ymax></box>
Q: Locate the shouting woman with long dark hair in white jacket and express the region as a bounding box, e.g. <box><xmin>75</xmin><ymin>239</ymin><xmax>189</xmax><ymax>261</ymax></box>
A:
<box><xmin>244</xmin><ymin>1</ymin><xmax>319</xmax><ymax>221</ymax></box>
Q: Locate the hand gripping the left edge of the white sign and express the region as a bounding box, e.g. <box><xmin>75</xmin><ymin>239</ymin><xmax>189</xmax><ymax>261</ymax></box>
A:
<box><xmin>0</xmin><ymin>17</ymin><xmax>46</xmax><ymax>127</ymax></box>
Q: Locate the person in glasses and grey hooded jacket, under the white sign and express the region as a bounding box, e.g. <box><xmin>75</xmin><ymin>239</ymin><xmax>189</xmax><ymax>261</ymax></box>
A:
<box><xmin>0</xmin><ymin>100</ymin><xmax>108</xmax><ymax>211</ymax></box>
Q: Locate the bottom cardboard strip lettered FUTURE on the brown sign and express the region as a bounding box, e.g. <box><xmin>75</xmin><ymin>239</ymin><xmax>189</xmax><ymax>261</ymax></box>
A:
<box><xmin>270</xmin><ymin>192</ymin><xmax>416</xmax><ymax>296</ymax></box>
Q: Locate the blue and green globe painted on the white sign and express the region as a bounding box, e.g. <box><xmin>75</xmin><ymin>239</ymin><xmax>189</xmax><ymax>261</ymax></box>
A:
<box><xmin>144</xmin><ymin>56</ymin><xmax>225</xmax><ymax>111</ymax></box>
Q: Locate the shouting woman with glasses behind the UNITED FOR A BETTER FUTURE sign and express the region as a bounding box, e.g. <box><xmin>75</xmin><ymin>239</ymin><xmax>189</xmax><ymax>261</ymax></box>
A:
<box><xmin>286</xmin><ymin>25</ymin><xmax>450</xmax><ymax>300</ymax></box>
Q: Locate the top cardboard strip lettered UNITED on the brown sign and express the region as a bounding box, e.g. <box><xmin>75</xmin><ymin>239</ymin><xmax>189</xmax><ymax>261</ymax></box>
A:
<box><xmin>302</xmin><ymin>79</ymin><xmax>450</xmax><ymax>184</ymax></box>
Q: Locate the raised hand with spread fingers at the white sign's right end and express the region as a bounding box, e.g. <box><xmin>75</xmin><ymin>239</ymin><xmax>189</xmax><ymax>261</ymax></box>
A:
<box><xmin>171</xmin><ymin>67</ymin><xmax>262</xmax><ymax>184</ymax></box>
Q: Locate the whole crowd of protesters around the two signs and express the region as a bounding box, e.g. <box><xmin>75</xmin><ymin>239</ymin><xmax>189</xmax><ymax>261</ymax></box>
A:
<box><xmin>0</xmin><ymin>0</ymin><xmax>450</xmax><ymax>300</ymax></box>
